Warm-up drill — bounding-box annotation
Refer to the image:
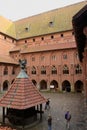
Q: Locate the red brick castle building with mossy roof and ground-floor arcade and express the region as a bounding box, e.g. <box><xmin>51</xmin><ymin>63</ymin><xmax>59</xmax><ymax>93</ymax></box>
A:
<box><xmin>0</xmin><ymin>1</ymin><xmax>86</xmax><ymax>92</ymax></box>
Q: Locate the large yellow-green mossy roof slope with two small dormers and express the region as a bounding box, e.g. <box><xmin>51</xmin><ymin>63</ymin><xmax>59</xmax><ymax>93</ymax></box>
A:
<box><xmin>14</xmin><ymin>1</ymin><xmax>87</xmax><ymax>39</ymax></box>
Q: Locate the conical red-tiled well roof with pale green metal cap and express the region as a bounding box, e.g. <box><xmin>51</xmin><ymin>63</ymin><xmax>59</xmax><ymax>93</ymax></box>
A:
<box><xmin>0</xmin><ymin>69</ymin><xmax>46</xmax><ymax>109</ymax></box>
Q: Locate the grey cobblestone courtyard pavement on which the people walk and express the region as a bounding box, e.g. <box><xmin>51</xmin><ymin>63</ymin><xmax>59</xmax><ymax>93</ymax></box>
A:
<box><xmin>0</xmin><ymin>92</ymin><xmax>86</xmax><ymax>130</ymax></box>
